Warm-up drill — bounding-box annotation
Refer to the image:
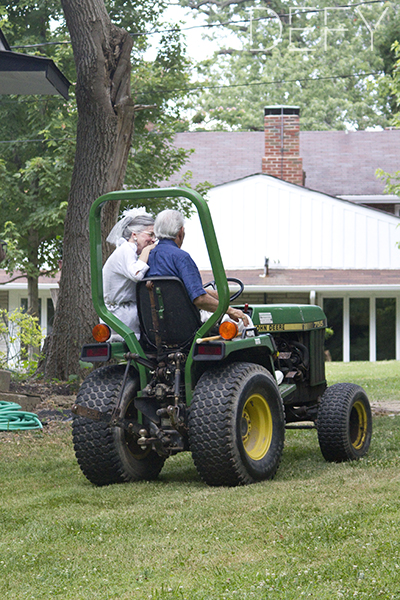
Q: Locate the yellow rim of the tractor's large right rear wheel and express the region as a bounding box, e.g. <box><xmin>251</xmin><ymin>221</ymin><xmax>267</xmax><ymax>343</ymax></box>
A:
<box><xmin>241</xmin><ymin>394</ymin><xmax>273</xmax><ymax>460</ymax></box>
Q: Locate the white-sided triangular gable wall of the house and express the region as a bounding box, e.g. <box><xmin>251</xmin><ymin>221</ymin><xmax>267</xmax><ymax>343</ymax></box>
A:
<box><xmin>183</xmin><ymin>175</ymin><xmax>400</xmax><ymax>269</ymax></box>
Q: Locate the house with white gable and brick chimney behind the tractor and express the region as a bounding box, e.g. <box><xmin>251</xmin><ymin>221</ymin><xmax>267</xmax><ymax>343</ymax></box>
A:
<box><xmin>165</xmin><ymin>107</ymin><xmax>400</xmax><ymax>361</ymax></box>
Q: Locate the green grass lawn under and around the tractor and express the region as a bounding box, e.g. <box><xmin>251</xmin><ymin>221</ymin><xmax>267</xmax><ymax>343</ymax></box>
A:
<box><xmin>0</xmin><ymin>361</ymin><xmax>400</xmax><ymax>600</ymax></box>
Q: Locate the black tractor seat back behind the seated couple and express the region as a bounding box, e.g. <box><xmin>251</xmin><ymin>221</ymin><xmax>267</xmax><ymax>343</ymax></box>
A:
<box><xmin>136</xmin><ymin>277</ymin><xmax>202</xmax><ymax>350</ymax></box>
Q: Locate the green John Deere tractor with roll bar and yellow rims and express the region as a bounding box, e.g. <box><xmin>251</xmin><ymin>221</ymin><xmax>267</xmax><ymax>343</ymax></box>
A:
<box><xmin>73</xmin><ymin>188</ymin><xmax>372</xmax><ymax>486</ymax></box>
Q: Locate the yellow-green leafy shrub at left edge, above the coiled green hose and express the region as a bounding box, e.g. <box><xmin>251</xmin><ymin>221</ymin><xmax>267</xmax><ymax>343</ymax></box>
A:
<box><xmin>0</xmin><ymin>309</ymin><xmax>43</xmax><ymax>375</ymax></box>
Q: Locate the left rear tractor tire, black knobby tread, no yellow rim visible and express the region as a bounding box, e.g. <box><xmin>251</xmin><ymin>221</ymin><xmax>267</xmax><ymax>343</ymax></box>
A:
<box><xmin>72</xmin><ymin>365</ymin><xmax>165</xmax><ymax>486</ymax></box>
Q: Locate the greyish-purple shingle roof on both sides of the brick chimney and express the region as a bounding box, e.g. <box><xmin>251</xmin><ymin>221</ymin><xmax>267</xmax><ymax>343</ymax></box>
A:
<box><xmin>169</xmin><ymin>129</ymin><xmax>400</xmax><ymax>196</ymax></box>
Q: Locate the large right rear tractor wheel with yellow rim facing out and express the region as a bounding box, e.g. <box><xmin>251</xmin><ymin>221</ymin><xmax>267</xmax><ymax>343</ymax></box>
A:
<box><xmin>189</xmin><ymin>362</ymin><xmax>285</xmax><ymax>486</ymax></box>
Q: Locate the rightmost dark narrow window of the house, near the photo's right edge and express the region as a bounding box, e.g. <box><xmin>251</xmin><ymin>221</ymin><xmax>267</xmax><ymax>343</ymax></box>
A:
<box><xmin>376</xmin><ymin>298</ymin><xmax>396</xmax><ymax>360</ymax></box>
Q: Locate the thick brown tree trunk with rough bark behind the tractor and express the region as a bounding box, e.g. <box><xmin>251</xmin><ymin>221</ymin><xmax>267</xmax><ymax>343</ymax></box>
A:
<box><xmin>45</xmin><ymin>0</ymin><xmax>134</xmax><ymax>380</ymax></box>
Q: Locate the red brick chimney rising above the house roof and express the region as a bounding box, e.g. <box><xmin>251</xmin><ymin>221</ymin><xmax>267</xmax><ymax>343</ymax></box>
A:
<box><xmin>262</xmin><ymin>106</ymin><xmax>304</xmax><ymax>185</ymax></box>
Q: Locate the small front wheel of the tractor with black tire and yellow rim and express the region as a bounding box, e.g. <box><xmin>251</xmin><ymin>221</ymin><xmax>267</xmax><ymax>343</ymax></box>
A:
<box><xmin>317</xmin><ymin>383</ymin><xmax>372</xmax><ymax>462</ymax></box>
